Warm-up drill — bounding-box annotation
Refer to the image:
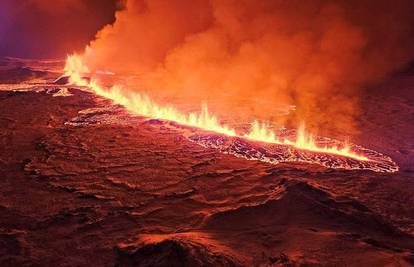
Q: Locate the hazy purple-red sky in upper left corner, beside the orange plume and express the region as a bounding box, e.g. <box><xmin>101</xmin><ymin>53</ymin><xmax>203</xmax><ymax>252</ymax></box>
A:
<box><xmin>0</xmin><ymin>0</ymin><xmax>116</xmax><ymax>58</ymax></box>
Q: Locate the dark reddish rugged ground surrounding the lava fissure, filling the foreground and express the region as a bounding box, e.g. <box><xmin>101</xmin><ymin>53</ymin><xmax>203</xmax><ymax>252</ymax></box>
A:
<box><xmin>0</xmin><ymin>59</ymin><xmax>414</xmax><ymax>266</ymax></box>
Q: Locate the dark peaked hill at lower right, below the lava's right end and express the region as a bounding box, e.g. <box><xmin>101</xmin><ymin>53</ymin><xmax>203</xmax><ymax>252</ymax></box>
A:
<box><xmin>205</xmin><ymin>181</ymin><xmax>402</xmax><ymax>236</ymax></box>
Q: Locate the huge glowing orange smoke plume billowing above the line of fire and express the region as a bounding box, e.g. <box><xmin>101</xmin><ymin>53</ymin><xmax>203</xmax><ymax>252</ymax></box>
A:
<box><xmin>81</xmin><ymin>0</ymin><xmax>414</xmax><ymax>133</ymax></box>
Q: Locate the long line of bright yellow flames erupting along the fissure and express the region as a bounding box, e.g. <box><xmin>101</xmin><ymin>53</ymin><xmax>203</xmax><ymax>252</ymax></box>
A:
<box><xmin>64</xmin><ymin>54</ymin><xmax>368</xmax><ymax>161</ymax></box>
